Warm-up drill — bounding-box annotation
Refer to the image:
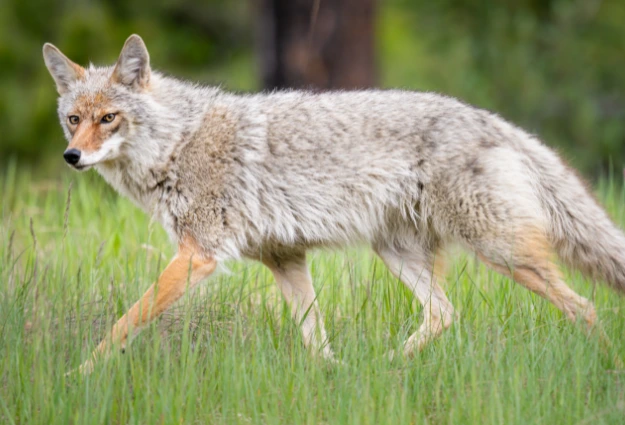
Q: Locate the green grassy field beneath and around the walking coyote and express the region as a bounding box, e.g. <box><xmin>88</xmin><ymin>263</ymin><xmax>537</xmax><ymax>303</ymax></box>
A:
<box><xmin>0</xmin><ymin>166</ymin><xmax>625</xmax><ymax>425</ymax></box>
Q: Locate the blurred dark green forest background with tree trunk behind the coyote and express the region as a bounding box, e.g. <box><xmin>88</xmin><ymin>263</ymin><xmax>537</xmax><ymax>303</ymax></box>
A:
<box><xmin>0</xmin><ymin>0</ymin><xmax>625</xmax><ymax>178</ymax></box>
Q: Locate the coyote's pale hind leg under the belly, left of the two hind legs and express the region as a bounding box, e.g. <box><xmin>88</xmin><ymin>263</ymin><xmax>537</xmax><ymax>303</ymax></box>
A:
<box><xmin>374</xmin><ymin>240</ymin><xmax>455</xmax><ymax>356</ymax></box>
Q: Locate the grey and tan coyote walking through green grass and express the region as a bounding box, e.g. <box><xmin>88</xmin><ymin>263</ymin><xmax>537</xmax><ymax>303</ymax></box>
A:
<box><xmin>43</xmin><ymin>35</ymin><xmax>625</xmax><ymax>373</ymax></box>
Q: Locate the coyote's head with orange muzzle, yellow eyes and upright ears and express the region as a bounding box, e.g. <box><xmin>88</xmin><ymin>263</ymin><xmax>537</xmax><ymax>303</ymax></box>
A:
<box><xmin>43</xmin><ymin>35</ymin><xmax>158</xmax><ymax>170</ymax></box>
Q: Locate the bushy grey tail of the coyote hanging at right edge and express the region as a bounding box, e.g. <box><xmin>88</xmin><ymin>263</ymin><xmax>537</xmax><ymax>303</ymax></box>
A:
<box><xmin>536</xmin><ymin>155</ymin><xmax>625</xmax><ymax>292</ymax></box>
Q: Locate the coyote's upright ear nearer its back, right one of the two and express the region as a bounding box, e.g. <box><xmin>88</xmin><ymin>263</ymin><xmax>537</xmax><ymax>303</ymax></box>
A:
<box><xmin>111</xmin><ymin>34</ymin><xmax>150</xmax><ymax>89</ymax></box>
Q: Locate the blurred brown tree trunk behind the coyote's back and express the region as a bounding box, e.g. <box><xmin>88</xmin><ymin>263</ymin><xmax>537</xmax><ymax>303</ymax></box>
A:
<box><xmin>257</xmin><ymin>0</ymin><xmax>375</xmax><ymax>90</ymax></box>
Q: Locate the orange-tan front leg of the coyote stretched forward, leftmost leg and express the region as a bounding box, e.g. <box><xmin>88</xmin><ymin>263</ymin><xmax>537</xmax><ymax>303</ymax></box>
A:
<box><xmin>71</xmin><ymin>238</ymin><xmax>217</xmax><ymax>374</ymax></box>
